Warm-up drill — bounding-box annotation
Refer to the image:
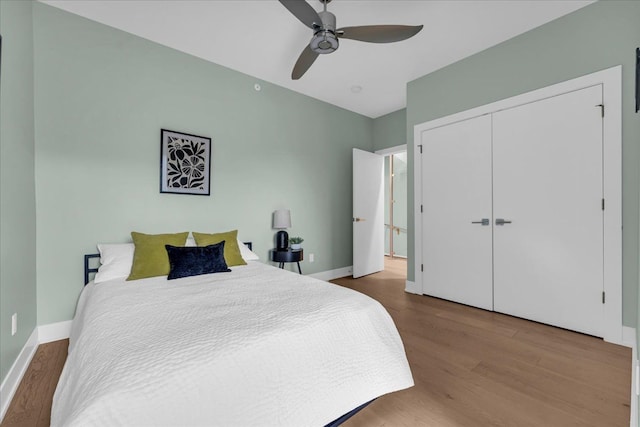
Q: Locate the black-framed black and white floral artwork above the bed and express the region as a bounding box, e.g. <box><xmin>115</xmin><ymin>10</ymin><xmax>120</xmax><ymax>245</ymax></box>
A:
<box><xmin>160</xmin><ymin>129</ymin><xmax>211</xmax><ymax>196</ymax></box>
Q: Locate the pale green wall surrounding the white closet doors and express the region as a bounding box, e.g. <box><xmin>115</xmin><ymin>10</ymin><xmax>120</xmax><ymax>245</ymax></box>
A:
<box><xmin>407</xmin><ymin>1</ymin><xmax>640</xmax><ymax>327</ymax></box>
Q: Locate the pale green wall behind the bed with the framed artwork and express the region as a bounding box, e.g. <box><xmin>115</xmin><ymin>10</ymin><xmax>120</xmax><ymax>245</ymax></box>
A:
<box><xmin>34</xmin><ymin>3</ymin><xmax>373</xmax><ymax>325</ymax></box>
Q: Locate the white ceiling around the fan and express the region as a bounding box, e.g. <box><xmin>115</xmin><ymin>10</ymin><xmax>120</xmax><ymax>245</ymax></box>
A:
<box><xmin>41</xmin><ymin>0</ymin><xmax>592</xmax><ymax>118</ymax></box>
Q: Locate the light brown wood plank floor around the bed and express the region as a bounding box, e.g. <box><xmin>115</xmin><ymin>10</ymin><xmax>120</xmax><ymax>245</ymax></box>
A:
<box><xmin>1</xmin><ymin>259</ymin><xmax>631</xmax><ymax>427</ymax></box>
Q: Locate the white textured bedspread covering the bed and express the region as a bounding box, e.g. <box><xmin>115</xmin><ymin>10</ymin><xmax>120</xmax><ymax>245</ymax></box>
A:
<box><xmin>51</xmin><ymin>262</ymin><xmax>413</xmax><ymax>427</ymax></box>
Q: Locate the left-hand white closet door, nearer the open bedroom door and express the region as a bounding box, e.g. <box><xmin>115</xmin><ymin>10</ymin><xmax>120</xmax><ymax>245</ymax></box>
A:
<box><xmin>421</xmin><ymin>116</ymin><xmax>493</xmax><ymax>310</ymax></box>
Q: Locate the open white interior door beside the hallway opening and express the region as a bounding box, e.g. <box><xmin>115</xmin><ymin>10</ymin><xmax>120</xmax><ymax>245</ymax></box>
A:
<box><xmin>353</xmin><ymin>148</ymin><xmax>384</xmax><ymax>278</ymax></box>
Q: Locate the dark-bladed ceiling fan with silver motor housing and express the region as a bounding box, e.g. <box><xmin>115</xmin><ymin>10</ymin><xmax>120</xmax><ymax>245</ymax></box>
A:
<box><xmin>278</xmin><ymin>0</ymin><xmax>422</xmax><ymax>80</ymax></box>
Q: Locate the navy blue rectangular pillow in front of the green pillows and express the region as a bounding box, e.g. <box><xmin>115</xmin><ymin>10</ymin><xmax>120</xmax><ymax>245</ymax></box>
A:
<box><xmin>165</xmin><ymin>240</ymin><xmax>231</xmax><ymax>280</ymax></box>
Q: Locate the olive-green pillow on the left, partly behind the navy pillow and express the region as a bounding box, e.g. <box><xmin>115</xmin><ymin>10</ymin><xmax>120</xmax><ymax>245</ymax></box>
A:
<box><xmin>127</xmin><ymin>231</ymin><xmax>189</xmax><ymax>280</ymax></box>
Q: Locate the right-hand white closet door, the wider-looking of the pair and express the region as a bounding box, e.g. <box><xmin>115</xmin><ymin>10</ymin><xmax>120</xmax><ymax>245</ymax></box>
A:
<box><xmin>493</xmin><ymin>85</ymin><xmax>603</xmax><ymax>336</ymax></box>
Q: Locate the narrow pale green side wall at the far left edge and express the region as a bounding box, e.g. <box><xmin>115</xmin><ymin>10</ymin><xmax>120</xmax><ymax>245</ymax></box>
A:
<box><xmin>0</xmin><ymin>1</ymin><xmax>37</xmax><ymax>382</ymax></box>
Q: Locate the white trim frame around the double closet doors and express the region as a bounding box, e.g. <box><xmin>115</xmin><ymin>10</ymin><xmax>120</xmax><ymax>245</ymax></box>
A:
<box><xmin>413</xmin><ymin>65</ymin><xmax>623</xmax><ymax>344</ymax></box>
